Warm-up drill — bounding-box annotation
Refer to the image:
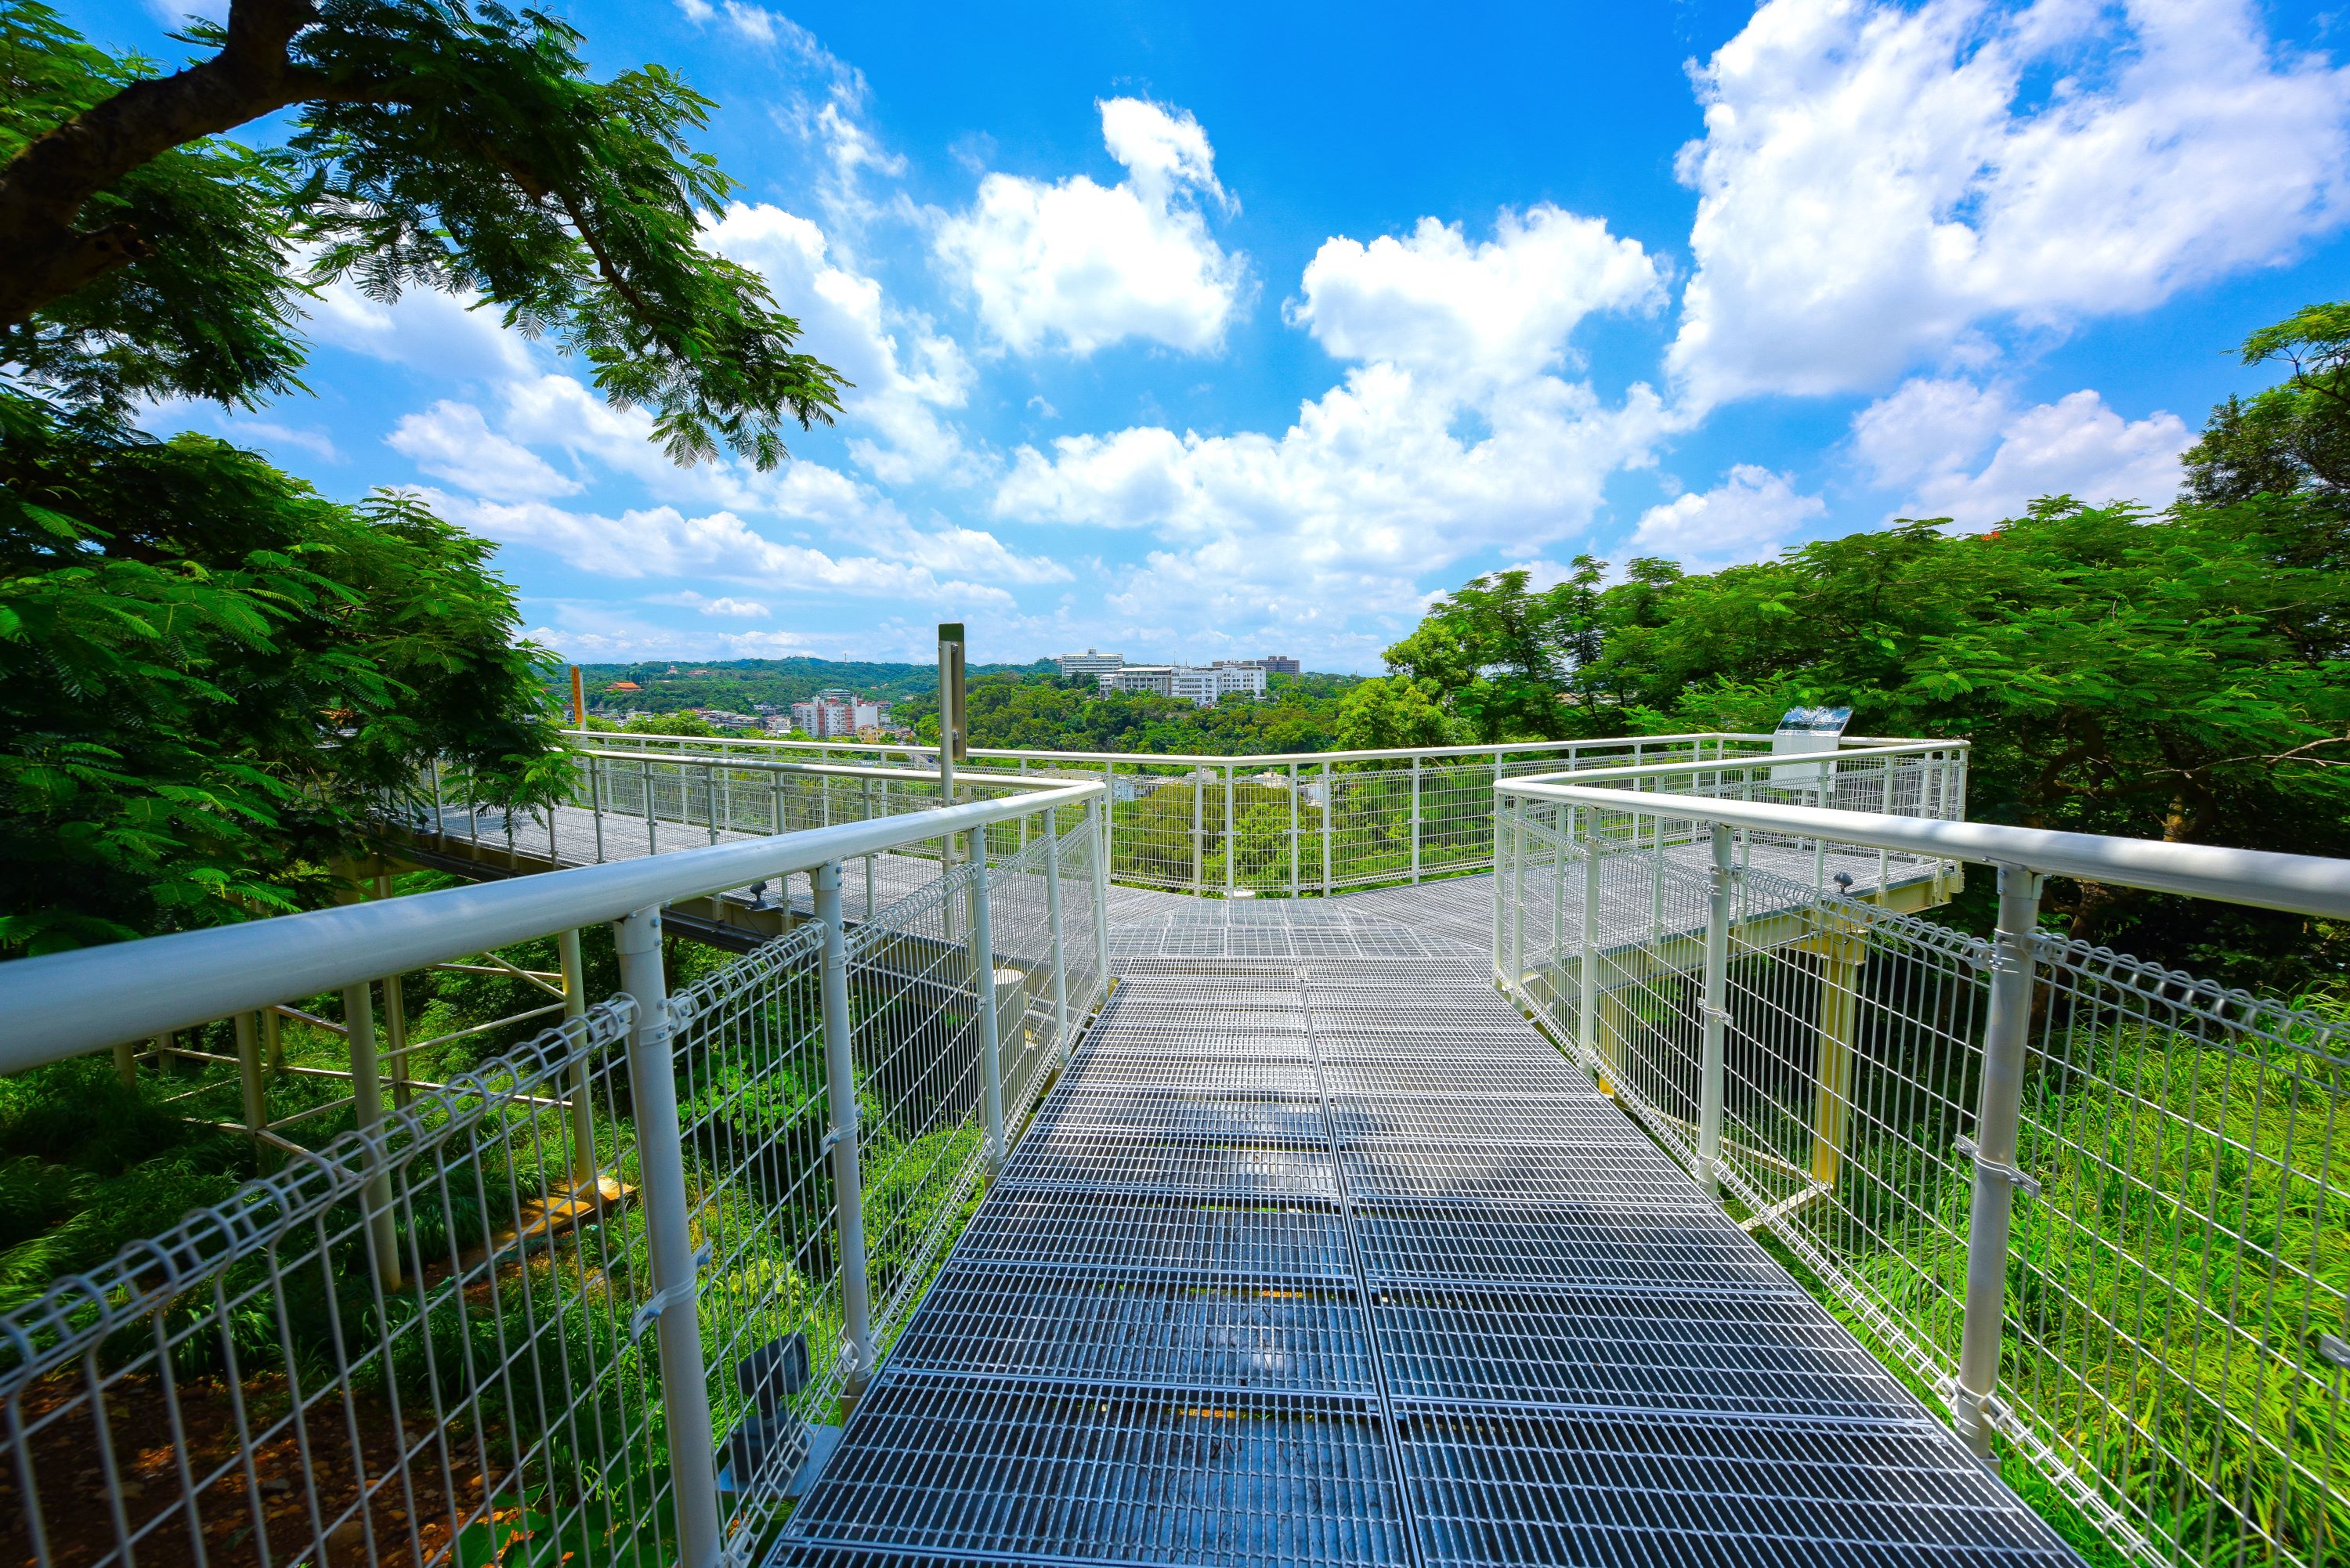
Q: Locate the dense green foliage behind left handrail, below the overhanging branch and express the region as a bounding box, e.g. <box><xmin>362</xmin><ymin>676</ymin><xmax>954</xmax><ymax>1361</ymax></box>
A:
<box><xmin>0</xmin><ymin>397</ymin><xmax>569</xmax><ymax>952</ymax></box>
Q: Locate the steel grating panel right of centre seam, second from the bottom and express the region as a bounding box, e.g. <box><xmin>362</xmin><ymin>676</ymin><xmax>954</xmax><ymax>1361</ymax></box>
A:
<box><xmin>1372</xmin><ymin>1286</ymin><xmax>1932</xmax><ymax>1427</ymax></box>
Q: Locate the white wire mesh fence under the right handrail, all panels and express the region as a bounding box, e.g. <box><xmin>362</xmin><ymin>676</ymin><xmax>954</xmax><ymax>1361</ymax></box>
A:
<box><xmin>1497</xmin><ymin>802</ymin><xmax>2350</xmax><ymax>1563</ymax></box>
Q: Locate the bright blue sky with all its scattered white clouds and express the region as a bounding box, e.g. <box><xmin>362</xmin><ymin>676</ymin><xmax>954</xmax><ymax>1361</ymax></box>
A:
<box><xmin>78</xmin><ymin>0</ymin><xmax>2350</xmax><ymax>670</ymax></box>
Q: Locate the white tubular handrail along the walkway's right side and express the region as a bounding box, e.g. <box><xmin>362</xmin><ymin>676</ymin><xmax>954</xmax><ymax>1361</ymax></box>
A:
<box><xmin>1495</xmin><ymin>773</ymin><xmax>2350</xmax><ymax>919</ymax></box>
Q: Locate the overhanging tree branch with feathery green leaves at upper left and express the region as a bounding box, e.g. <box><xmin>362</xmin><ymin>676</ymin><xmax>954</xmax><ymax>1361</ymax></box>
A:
<box><xmin>0</xmin><ymin>0</ymin><xmax>844</xmax><ymax>468</ymax></box>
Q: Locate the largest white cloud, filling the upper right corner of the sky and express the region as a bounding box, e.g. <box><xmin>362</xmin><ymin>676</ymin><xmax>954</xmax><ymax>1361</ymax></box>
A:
<box><xmin>1668</xmin><ymin>0</ymin><xmax>2350</xmax><ymax>402</ymax></box>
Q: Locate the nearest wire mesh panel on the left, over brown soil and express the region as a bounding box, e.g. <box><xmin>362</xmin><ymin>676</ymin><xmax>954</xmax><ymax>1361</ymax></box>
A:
<box><xmin>0</xmin><ymin>999</ymin><xmax>674</xmax><ymax>1568</ymax></box>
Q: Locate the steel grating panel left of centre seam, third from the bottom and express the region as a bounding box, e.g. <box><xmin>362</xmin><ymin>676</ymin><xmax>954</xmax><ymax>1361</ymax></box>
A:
<box><xmin>954</xmin><ymin>1190</ymin><xmax>1354</xmax><ymax>1279</ymax></box>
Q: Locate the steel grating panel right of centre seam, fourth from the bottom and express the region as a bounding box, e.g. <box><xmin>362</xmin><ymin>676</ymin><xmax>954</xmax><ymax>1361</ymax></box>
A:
<box><xmin>1340</xmin><ymin>1140</ymin><xmax>1720</xmax><ymax>1216</ymax></box>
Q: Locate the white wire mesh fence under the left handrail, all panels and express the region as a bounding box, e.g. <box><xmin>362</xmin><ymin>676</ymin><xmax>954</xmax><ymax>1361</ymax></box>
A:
<box><xmin>0</xmin><ymin>809</ymin><xmax>1102</xmax><ymax>1568</ymax></box>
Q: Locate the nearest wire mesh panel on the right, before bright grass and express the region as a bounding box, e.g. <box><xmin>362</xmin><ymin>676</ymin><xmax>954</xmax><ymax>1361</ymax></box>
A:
<box><xmin>2000</xmin><ymin>936</ymin><xmax>2350</xmax><ymax>1563</ymax></box>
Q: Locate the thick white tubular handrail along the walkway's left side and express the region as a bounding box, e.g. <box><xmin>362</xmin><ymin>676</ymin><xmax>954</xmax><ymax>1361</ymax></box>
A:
<box><xmin>0</xmin><ymin>780</ymin><xmax>1102</xmax><ymax>1072</ymax></box>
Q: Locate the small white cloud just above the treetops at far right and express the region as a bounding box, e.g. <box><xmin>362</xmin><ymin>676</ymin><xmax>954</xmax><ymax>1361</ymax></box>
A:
<box><xmin>1852</xmin><ymin>378</ymin><xmax>2193</xmax><ymax>529</ymax></box>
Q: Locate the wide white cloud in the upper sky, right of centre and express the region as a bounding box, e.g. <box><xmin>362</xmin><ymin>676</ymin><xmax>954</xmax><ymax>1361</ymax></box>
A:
<box><xmin>1288</xmin><ymin>204</ymin><xmax>1664</xmax><ymax>381</ymax></box>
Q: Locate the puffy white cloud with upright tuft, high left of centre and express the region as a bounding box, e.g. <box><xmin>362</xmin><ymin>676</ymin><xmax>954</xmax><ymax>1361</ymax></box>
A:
<box><xmin>935</xmin><ymin>99</ymin><xmax>1246</xmax><ymax>355</ymax></box>
